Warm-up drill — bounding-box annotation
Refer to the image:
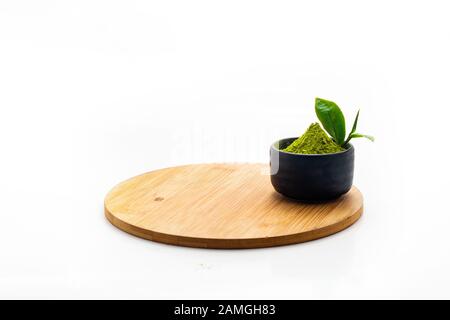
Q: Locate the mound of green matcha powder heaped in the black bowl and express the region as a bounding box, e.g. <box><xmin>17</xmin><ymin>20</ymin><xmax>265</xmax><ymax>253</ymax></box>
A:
<box><xmin>282</xmin><ymin>123</ymin><xmax>345</xmax><ymax>154</ymax></box>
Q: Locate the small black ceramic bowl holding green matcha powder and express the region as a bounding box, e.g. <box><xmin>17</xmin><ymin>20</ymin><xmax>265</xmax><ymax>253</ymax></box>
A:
<box><xmin>270</xmin><ymin>138</ymin><xmax>355</xmax><ymax>202</ymax></box>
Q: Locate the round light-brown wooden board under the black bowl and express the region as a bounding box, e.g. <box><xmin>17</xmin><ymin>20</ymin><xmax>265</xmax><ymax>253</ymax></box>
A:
<box><xmin>105</xmin><ymin>164</ymin><xmax>363</xmax><ymax>248</ymax></box>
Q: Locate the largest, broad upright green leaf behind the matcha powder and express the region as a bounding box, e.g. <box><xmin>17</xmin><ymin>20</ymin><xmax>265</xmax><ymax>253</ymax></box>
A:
<box><xmin>316</xmin><ymin>98</ymin><xmax>345</xmax><ymax>145</ymax></box>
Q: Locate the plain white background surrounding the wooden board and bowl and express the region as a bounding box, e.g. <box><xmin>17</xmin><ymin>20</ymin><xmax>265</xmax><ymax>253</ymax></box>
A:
<box><xmin>0</xmin><ymin>0</ymin><xmax>450</xmax><ymax>299</ymax></box>
